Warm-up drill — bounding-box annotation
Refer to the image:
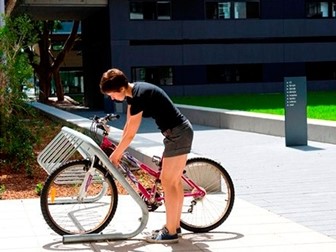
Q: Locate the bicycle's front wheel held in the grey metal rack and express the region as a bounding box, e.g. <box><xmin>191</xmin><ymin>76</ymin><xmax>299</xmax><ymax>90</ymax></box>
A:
<box><xmin>40</xmin><ymin>160</ymin><xmax>118</xmax><ymax>235</ymax></box>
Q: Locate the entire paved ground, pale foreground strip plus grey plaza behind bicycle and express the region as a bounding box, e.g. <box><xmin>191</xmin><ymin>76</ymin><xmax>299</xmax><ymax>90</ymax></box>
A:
<box><xmin>0</xmin><ymin>105</ymin><xmax>336</xmax><ymax>252</ymax></box>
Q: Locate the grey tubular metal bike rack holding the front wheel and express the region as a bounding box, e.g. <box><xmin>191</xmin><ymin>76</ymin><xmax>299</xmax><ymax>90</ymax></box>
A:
<box><xmin>37</xmin><ymin>127</ymin><xmax>149</xmax><ymax>244</ymax></box>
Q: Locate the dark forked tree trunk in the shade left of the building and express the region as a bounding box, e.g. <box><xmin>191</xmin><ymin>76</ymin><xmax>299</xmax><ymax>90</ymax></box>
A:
<box><xmin>26</xmin><ymin>20</ymin><xmax>80</xmax><ymax>103</ymax></box>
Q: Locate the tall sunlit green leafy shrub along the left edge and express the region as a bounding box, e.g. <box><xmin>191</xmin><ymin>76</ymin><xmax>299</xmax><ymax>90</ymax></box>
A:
<box><xmin>0</xmin><ymin>15</ymin><xmax>36</xmax><ymax>175</ymax></box>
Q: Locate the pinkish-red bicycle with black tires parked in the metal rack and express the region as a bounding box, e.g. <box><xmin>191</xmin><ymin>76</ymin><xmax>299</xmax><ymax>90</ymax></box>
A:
<box><xmin>40</xmin><ymin>114</ymin><xmax>235</xmax><ymax>235</ymax></box>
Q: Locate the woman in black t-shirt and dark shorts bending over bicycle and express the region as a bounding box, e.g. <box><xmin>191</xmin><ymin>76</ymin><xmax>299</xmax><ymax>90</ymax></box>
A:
<box><xmin>100</xmin><ymin>68</ymin><xmax>193</xmax><ymax>243</ymax></box>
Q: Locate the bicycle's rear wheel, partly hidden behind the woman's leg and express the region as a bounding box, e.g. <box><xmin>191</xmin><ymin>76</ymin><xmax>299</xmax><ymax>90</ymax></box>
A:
<box><xmin>180</xmin><ymin>157</ymin><xmax>235</xmax><ymax>233</ymax></box>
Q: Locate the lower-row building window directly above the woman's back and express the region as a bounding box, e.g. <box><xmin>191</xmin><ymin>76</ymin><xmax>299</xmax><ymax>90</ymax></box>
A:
<box><xmin>132</xmin><ymin>67</ymin><xmax>173</xmax><ymax>86</ymax></box>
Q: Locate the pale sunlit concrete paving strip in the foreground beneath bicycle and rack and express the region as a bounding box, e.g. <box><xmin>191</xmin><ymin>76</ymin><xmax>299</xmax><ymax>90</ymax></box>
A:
<box><xmin>0</xmin><ymin>196</ymin><xmax>336</xmax><ymax>252</ymax></box>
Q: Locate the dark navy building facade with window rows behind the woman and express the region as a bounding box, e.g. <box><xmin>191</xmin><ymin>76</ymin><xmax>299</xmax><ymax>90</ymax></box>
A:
<box><xmin>82</xmin><ymin>0</ymin><xmax>336</xmax><ymax>109</ymax></box>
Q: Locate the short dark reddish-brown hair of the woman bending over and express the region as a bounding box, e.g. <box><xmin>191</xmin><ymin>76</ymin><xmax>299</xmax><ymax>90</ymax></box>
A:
<box><xmin>99</xmin><ymin>68</ymin><xmax>128</xmax><ymax>94</ymax></box>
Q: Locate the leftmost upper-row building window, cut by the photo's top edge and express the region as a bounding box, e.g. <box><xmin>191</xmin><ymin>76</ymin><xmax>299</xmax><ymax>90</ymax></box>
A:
<box><xmin>130</xmin><ymin>0</ymin><xmax>171</xmax><ymax>20</ymax></box>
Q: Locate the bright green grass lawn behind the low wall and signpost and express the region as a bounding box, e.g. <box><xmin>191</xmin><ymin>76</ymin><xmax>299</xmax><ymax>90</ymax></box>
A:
<box><xmin>172</xmin><ymin>91</ymin><xmax>336</xmax><ymax>121</ymax></box>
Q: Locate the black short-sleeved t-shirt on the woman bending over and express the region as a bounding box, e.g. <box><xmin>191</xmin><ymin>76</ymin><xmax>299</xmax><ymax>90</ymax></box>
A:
<box><xmin>126</xmin><ymin>82</ymin><xmax>186</xmax><ymax>132</ymax></box>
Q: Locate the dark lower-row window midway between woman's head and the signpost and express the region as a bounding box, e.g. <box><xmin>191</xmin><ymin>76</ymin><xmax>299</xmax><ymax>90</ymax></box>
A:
<box><xmin>207</xmin><ymin>64</ymin><xmax>262</xmax><ymax>83</ymax></box>
